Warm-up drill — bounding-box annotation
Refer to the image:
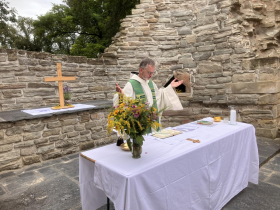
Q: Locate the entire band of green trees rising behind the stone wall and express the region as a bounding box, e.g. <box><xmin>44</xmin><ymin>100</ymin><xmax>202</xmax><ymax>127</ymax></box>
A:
<box><xmin>0</xmin><ymin>0</ymin><xmax>140</xmax><ymax>58</ymax></box>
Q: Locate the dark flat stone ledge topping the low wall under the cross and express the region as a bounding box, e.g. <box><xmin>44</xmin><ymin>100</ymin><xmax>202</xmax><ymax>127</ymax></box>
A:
<box><xmin>0</xmin><ymin>100</ymin><xmax>113</xmax><ymax>123</ymax></box>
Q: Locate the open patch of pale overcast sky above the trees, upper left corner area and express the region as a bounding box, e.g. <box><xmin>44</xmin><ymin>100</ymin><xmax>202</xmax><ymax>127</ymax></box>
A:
<box><xmin>6</xmin><ymin>0</ymin><xmax>63</xmax><ymax>19</ymax></box>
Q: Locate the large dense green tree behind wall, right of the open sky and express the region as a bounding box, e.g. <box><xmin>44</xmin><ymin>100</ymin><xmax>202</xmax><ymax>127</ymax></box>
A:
<box><xmin>34</xmin><ymin>0</ymin><xmax>140</xmax><ymax>57</ymax></box>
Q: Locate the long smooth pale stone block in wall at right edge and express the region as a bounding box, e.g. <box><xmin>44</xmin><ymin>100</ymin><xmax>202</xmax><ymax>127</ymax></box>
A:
<box><xmin>226</xmin><ymin>81</ymin><xmax>280</xmax><ymax>94</ymax></box>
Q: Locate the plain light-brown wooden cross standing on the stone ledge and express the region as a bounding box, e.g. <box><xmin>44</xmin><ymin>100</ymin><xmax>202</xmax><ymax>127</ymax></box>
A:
<box><xmin>44</xmin><ymin>63</ymin><xmax>76</xmax><ymax>109</ymax></box>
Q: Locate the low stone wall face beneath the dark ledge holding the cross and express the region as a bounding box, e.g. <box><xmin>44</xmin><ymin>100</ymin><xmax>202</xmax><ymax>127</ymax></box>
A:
<box><xmin>0</xmin><ymin>110</ymin><xmax>116</xmax><ymax>172</ymax></box>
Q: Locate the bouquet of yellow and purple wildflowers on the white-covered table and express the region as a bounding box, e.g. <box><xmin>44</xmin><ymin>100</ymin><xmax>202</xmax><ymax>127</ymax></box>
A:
<box><xmin>107</xmin><ymin>95</ymin><xmax>164</xmax><ymax>150</ymax></box>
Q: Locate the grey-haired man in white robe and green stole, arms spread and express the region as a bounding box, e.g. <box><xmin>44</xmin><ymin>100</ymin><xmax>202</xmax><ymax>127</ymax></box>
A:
<box><xmin>113</xmin><ymin>58</ymin><xmax>183</xmax><ymax>110</ymax></box>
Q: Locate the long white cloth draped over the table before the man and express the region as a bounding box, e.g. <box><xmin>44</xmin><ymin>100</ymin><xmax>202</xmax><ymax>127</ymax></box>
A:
<box><xmin>79</xmin><ymin>122</ymin><xmax>259</xmax><ymax>210</ymax></box>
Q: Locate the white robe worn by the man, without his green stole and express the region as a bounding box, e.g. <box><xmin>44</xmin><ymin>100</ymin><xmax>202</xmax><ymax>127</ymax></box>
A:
<box><xmin>113</xmin><ymin>74</ymin><xmax>183</xmax><ymax>110</ymax></box>
